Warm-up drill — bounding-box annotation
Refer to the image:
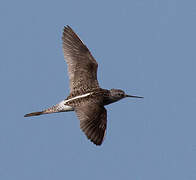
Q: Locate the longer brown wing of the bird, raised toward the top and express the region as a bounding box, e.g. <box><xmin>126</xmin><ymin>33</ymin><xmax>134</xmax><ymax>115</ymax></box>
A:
<box><xmin>62</xmin><ymin>26</ymin><xmax>99</xmax><ymax>92</ymax></box>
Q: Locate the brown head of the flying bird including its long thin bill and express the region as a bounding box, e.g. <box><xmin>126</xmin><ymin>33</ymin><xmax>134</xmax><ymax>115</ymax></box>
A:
<box><xmin>110</xmin><ymin>89</ymin><xmax>143</xmax><ymax>101</ymax></box>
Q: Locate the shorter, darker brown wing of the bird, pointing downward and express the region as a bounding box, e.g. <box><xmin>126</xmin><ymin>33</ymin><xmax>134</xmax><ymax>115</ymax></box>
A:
<box><xmin>75</xmin><ymin>102</ymin><xmax>107</xmax><ymax>145</ymax></box>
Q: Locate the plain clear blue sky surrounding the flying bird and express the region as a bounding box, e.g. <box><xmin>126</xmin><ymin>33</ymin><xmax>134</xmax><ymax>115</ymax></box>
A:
<box><xmin>0</xmin><ymin>0</ymin><xmax>196</xmax><ymax>180</ymax></box>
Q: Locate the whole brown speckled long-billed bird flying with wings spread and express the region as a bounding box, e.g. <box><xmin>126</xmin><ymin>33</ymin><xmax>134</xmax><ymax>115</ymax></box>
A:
<box><xmin>24</xmin><ymin>26</ymin><xmax>143</xmax><ymax>145</ymax></box>
